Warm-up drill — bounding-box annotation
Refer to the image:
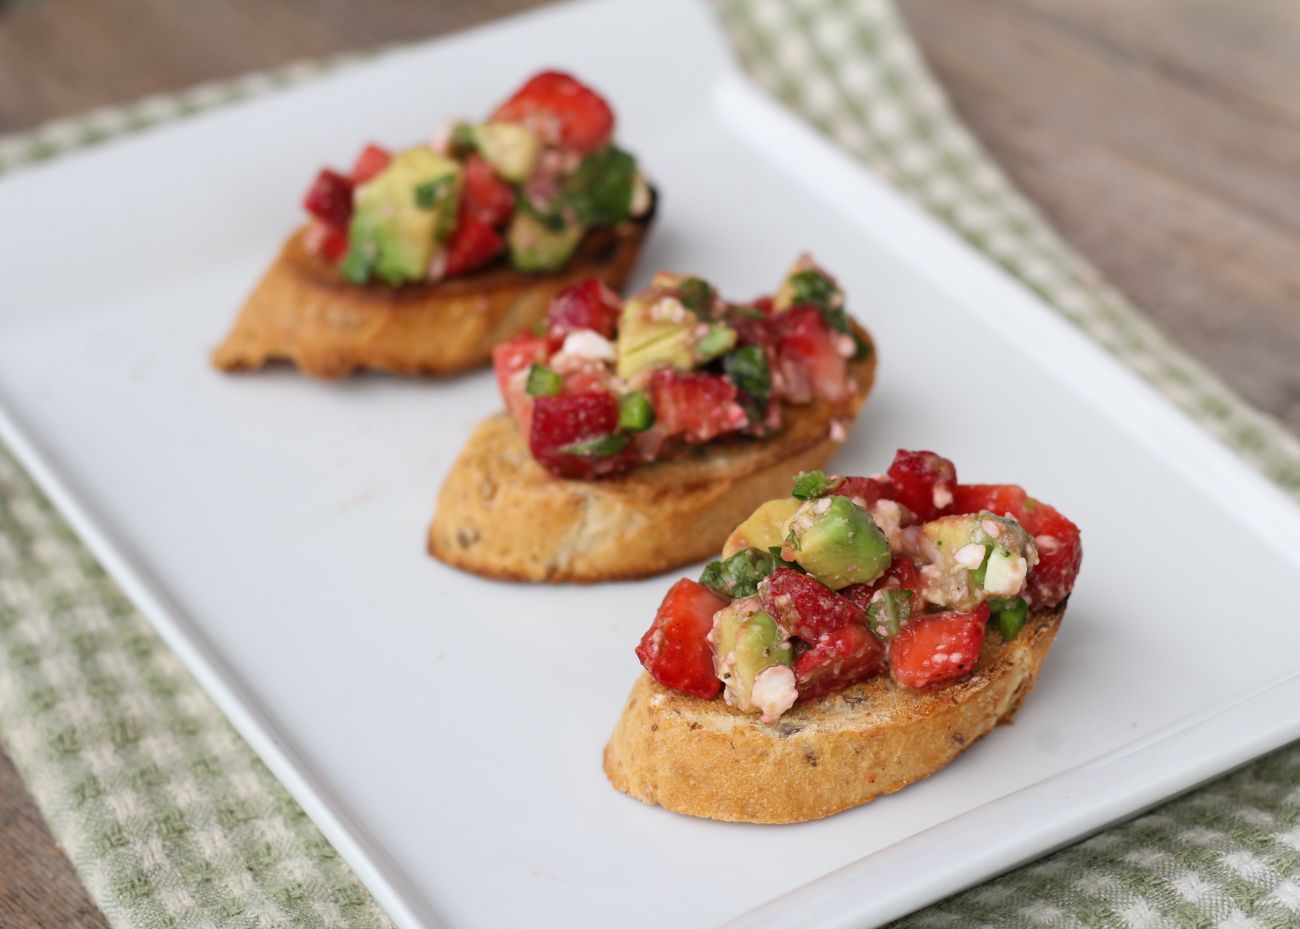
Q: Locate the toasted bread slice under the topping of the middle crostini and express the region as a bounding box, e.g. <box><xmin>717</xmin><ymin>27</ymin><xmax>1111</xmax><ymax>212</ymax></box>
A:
<box><xmin>429</xmin><ymin>329</ymin><xmax>876</xmax><ymax>583</ymax></box>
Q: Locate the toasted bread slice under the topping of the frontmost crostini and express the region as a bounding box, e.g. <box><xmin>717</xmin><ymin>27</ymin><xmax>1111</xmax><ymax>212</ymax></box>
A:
<box><xmin>605</xmin><ymin>603</ymin><xmax>1065</xmax><ymax>822</ymax></box>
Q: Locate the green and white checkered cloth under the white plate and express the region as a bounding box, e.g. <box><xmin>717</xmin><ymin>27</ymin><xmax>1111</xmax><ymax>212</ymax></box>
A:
<box><xmin>0</xmin><ymin>0</ymin><xmax>1300</xmax><ymax>929</ymax></box>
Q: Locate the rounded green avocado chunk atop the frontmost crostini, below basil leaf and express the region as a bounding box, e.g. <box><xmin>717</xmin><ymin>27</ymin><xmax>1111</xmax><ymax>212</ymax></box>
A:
<box><xmin>783</xmin><ymin>496</ymin><xmax>893</xmax><ymax>590</ymax></box>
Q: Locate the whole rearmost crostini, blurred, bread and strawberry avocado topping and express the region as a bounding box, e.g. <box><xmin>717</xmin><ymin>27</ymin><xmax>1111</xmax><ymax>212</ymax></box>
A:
<box><xmin>212</xmin><ymin>71</ymin><xmax>655</xmax><ymax>378</ymax></box>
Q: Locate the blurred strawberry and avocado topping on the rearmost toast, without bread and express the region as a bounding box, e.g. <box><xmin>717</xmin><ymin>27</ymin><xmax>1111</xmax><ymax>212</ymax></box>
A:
<box><xmin>303</xmin><ymin>71</ymin><xmax>653</xmax><ymax>285</ymax></box>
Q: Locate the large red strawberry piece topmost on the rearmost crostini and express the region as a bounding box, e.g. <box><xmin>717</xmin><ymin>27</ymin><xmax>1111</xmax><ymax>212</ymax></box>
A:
<box><xmin>491</xmin><ymin>71</ymin><xmax>614</xmax><ymax>155</ymax></box>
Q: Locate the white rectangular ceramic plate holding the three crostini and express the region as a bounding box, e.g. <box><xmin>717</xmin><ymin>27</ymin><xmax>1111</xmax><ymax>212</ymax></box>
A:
<box><xmin>0</xmin><ymin>0</ymin><xmax>1300</xmax><ymax>929</ymax></box>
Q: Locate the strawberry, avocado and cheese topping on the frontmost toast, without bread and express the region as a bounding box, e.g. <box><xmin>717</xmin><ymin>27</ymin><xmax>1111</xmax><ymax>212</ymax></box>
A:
<box><xmin>637</xmin><ymin>451</ymin><xmax>1083</xmax><ymax>724</ymax></box>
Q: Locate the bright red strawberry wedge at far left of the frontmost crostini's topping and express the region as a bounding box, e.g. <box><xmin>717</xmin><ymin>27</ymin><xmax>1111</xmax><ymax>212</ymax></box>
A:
<box><xmin>637</xmin><ymin>578</ymin><xmax>728</xmax><ymax>700</ymax></box>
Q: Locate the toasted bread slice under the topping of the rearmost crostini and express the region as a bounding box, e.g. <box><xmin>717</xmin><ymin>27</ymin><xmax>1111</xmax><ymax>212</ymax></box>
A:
<box><xmin>212</xmin><ymin>216</ymin><xmax>651</xmax><ymax>378</ymax></box>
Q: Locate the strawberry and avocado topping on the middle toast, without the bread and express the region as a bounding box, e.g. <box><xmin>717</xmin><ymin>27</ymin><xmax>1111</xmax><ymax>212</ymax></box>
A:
<box><xmin>493</xmin><ymin>256</ymin><xmax>867</xmax><ymax>478</ymax></box>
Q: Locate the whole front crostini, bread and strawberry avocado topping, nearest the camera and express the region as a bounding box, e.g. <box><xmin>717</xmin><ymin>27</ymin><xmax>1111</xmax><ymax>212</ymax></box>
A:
<box><xmin>605</xmin><ymin>451</ymin><xmax>1083</xmax><ymax>822</ymax></box>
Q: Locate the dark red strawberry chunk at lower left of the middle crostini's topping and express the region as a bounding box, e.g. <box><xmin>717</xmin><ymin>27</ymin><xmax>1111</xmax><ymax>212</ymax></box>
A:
<box><xmin>528</xmin><ymin>392</ymin><xmax>632</xmax><ymax>478</ymax></box>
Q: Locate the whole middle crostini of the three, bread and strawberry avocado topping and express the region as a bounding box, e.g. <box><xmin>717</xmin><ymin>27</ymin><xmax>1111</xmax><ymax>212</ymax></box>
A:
<box><xmin>428</xmin><ymin>256</ymin><xmax>875</xmax><ymax>582</ymax></box>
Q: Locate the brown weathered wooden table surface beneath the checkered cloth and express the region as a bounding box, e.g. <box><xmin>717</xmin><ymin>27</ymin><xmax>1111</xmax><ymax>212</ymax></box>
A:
<box><xmin>0</xmin><ymin>0</ymin><xmax>1300</xmax><ymax>929</ymax></box>
